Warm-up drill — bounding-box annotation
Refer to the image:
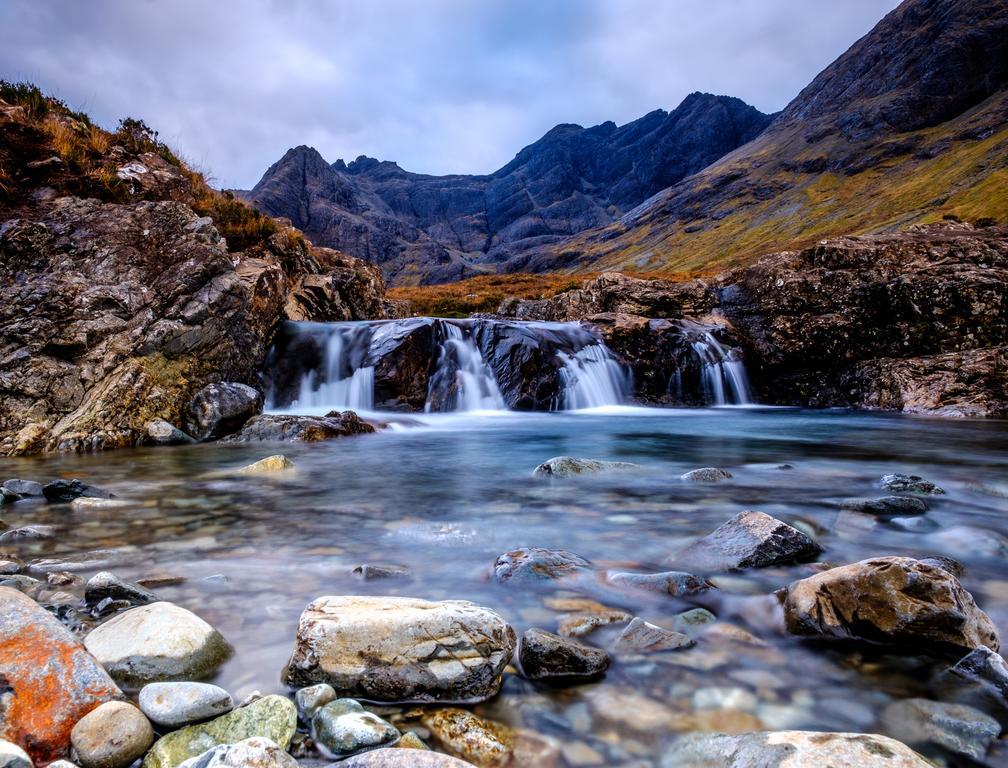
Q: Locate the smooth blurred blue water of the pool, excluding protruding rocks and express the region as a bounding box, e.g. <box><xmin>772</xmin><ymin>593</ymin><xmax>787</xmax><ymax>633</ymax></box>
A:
<box><xmin>0</xmin><ymin>407</ymin><xmax>1008</xmax><ymax>765</ymax></box>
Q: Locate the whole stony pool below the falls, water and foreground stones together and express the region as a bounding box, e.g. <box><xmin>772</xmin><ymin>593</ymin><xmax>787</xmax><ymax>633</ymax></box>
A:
<box><xmin>0</xmin><ymin>409</ymin><xmax>1008</xmax><ymax>768</ymax></box>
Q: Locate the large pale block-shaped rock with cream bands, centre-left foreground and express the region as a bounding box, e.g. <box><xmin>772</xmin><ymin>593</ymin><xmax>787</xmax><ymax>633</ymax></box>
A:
<box><xmin>283</xmin><ymin>597</ymin><xmax>515</xmax><ymax>701</ymax></box>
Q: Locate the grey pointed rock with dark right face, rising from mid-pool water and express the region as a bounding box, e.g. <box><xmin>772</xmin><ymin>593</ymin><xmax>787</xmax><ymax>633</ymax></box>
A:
<box><xmin>672</xmin><ymin>511</ymin><xmax>823</xmax><ymax>572</ymax></box>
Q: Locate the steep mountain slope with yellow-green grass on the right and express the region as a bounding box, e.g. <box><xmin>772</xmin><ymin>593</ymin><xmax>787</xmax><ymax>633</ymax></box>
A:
<box><xmin>540</xmin><ymin>0</ymin><xmax>1008</xmax><ymax>271</ymax></box>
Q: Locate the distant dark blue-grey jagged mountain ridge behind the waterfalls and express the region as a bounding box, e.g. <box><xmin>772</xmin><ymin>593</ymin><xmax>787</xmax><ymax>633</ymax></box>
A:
<box><xmin>244</xmin><ymin>93</ymin><xmax>771</xmax><ymax>283</ymax></box>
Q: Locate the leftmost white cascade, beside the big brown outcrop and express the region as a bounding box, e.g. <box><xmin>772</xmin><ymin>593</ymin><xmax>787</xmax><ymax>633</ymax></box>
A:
<box><xmin>293</xmin><ymin>326</ymin><xmax>375</xmax><ymax>410</ymax></box>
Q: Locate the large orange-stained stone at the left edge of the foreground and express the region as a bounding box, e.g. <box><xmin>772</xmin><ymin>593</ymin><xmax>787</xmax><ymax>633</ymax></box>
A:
<box><xmin>0</xmin><ymin>587</ymin><xmax>122</xmax><ymax>763</ymax></box>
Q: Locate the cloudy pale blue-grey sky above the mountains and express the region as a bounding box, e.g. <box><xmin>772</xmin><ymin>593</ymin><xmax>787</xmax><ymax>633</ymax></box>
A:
<box><xmin>0</xmin><ymin>0</ymin><xmax>897</xmax><ymax>188</ymax></box>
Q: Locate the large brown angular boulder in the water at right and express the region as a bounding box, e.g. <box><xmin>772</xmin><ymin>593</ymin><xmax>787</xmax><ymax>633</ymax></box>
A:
<box><xmin>784</xmin><ymin>557</ymin><xmax>1000</xmax><ymax>652</ymax></box>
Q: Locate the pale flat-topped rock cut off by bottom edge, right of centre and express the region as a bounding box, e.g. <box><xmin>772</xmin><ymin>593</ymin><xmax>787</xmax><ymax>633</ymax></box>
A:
<box><xmin>661</xmin><ymin>731</ymin><xmax>933</xmax><ymax>768</ymax></box>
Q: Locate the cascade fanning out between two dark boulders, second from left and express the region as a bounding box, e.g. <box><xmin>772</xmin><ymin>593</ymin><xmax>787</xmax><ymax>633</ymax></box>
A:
<box><xmin>423</xmin><ymin>323</ymin><xmax>507</xmax><ymax>413</ymax></box>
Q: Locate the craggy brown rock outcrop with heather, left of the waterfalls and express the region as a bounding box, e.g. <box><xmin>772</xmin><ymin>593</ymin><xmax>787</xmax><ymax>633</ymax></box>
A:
<box><xmin>0</xmin><ymin>97</ymin><xmax>390</xmax><ymax>454</ymax></box>
